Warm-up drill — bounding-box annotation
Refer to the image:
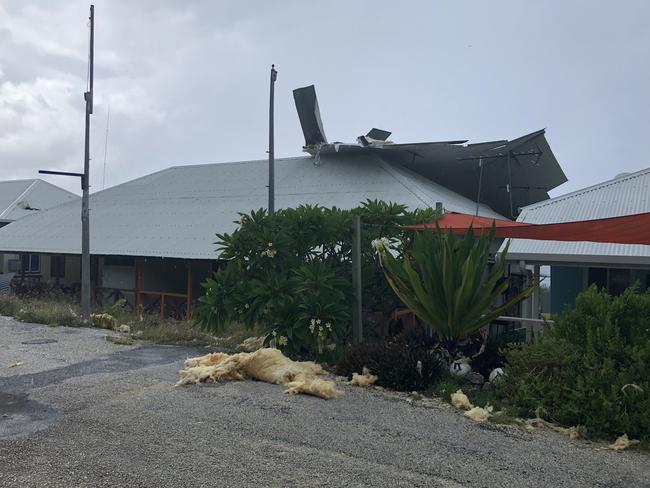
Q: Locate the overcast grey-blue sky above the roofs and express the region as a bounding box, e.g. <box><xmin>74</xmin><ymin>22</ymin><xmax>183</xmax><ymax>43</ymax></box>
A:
<box><xmin>0</xmin><ymin>0</ymin><xmax>650</xmax><ymax>195</ymax></box>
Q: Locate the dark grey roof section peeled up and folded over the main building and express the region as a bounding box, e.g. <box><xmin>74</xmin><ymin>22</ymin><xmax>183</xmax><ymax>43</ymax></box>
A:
<box><xmin>293</xmin><ymin>85</ymin><xmax>567</xmax><ymax>218</ymax></box>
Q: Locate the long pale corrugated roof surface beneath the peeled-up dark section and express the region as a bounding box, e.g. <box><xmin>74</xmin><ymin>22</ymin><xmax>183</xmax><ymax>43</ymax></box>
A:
<box><xmin>0</xmin><ymin>156</ymin><xmax>503</xmax><ymax>259</ymax></box>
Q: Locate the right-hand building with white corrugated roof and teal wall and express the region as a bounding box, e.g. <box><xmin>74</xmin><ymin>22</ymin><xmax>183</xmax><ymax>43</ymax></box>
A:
<box><xmin>508</xmin><ymin>168</ymin><xmax>650</xmax><ymax>313</ymax></box>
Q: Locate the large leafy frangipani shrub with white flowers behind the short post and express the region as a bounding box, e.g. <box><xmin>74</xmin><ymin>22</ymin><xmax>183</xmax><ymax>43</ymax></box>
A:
<box><xmin>195</xmin><ymin>201</ymin><xmax>436</xmax><ymax>356</ymax></box>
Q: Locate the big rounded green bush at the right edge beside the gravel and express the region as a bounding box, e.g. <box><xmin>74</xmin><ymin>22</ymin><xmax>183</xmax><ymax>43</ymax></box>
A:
<box><xmin>500</xmin><ymin>287</ymin><xmax>650</xmax><ymax>440</ymax></box>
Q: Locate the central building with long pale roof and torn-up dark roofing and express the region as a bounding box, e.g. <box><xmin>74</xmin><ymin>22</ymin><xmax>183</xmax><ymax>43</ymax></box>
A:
<box><xmin>0</xmin><ymin>86</ymin><xmax>566</xmax><ymax>315</ymax></box>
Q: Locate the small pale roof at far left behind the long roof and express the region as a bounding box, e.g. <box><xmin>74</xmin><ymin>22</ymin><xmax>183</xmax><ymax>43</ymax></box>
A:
<box><xmin>0</xmin><ymin>179</ymin><xmax>79</xmax><ymax>222</ymax></box>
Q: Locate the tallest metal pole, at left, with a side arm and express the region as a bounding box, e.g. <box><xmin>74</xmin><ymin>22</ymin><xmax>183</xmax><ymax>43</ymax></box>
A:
<box><xmin>81</xmin><ymin>5</ymin><xmax>95</xmax><ymax>322</ymax></box>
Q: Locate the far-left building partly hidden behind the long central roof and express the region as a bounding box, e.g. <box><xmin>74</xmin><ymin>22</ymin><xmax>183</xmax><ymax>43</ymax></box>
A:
<box><xmin>0</xmin><ymin>179</ymin><xmax>80</xmax><ymax>281</ymax></box>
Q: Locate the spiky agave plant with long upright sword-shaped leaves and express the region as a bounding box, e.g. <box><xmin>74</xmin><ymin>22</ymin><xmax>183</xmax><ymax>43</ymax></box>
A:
<box><xmin>373</xmin><ymin>228</ymin><xmax>533</xmax><ymax>350</ymax></box>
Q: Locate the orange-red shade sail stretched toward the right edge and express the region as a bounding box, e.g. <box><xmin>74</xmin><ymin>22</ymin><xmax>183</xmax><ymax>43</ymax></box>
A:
<box><xmin>407</xmin><ymin>212</ymin><xmax>650</xmax><ymax>245</ymax></box>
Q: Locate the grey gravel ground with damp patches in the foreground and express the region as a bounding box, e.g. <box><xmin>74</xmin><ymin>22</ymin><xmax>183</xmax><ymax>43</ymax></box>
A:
<box><xmin>0</xmin><ymin>318</ymin><xmax>650</xmax><ymax>488</ymax></box>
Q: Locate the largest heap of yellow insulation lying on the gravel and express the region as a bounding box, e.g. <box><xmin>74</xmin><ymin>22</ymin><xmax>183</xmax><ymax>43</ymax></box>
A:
<box><xmin>176</xmin><ymin>348</ymin><xmax>343</xmax><ymax>400</ymax></box>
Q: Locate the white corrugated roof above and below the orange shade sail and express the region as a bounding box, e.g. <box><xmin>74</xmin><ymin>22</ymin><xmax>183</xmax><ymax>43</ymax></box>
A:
<box><xmin>508</xmin><ymin>168</ymin><xmax>650</xmax><ymax>266</ymax></box>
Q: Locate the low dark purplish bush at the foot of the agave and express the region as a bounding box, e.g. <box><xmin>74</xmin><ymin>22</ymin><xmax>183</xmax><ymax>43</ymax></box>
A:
<box><xmin>335</xmin><ymin>338</ymin><xmax>445</xmax><ymax>391</ymax></box>
